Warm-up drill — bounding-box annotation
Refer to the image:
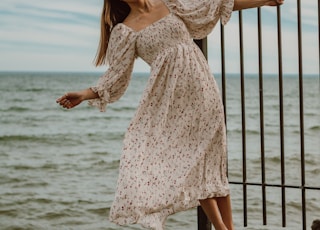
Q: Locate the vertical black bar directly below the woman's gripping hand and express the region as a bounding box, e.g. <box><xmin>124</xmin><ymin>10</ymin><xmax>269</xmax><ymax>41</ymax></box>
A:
<box><xmin>277</xmin><ymin>6</ymin><xmax>286</xmax><ymax>227</ymax></box>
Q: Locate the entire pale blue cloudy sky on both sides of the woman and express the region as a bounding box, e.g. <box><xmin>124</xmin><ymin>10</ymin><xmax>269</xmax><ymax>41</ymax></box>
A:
<box><xmin>0</xmin><ymin>0</ymin><xmax>319</xmax><ymax>74</ymax></box>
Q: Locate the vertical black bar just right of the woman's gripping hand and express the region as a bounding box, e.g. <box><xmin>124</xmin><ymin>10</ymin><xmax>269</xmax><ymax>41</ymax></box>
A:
<box><xmin>297</xmin><ymin>0</ymin><xmax>307</xmax><ymax>230</ymax></box>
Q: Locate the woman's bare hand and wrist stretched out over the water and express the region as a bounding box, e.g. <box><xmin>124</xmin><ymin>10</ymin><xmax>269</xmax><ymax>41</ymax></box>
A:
<box><xmin>56</xmin><ymin>88</ymin><xmax>99</xmax><ymax>109</ymax></box>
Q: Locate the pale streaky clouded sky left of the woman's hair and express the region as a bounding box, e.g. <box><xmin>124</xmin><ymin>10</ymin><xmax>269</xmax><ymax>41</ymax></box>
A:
<box><xmin>0</xmin><ymin>0</ymin><xmax>101</xmax><ymax>70</ymax></box>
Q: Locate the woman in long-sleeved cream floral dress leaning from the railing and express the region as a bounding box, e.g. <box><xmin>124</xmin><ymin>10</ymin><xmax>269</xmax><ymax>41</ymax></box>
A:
<box><xmin>57</xmin><ymin>0</ymin><xmax>283</xmax><ymax>230</ymax></box>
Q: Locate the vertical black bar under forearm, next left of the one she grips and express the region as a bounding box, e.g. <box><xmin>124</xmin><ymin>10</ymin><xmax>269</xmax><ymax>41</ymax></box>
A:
<box><xmin>258</xmin><ymin>8</ymin><xmax>267</xmax><ymax>225</ymax></box>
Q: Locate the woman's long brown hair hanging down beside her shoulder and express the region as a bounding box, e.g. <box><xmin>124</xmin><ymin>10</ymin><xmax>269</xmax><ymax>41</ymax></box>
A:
<box><xmin>95</xmin><ymin>0</ymin><xmax>130</xmax><ymax>66</ymax></box>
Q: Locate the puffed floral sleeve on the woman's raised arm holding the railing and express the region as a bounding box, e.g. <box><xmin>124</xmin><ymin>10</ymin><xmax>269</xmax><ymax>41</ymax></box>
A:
<box><xmin>164</xmin><ymin>0</ymin><xmax>234</xmax><ymax>39</ymax></box>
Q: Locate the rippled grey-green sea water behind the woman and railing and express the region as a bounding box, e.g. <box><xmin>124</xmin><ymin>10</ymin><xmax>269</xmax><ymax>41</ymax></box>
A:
<box><xmin>0</xmin><ymin>73</ymin><xmax>320</xmax><ymax>230</ymax></box>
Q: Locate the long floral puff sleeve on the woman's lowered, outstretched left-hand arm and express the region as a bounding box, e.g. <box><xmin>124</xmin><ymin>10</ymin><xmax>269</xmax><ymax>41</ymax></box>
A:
<box><xmin>89</xmin><ymin>24</ymin><xmax>136</xmax><ymax>112</ymax></box>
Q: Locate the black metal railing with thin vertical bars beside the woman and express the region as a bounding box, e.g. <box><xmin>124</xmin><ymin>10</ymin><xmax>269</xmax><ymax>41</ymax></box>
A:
<box><xmin>195</xmin><ymin>0</ymin><xmax>320</xmax><ymax>230</ymax></box>
